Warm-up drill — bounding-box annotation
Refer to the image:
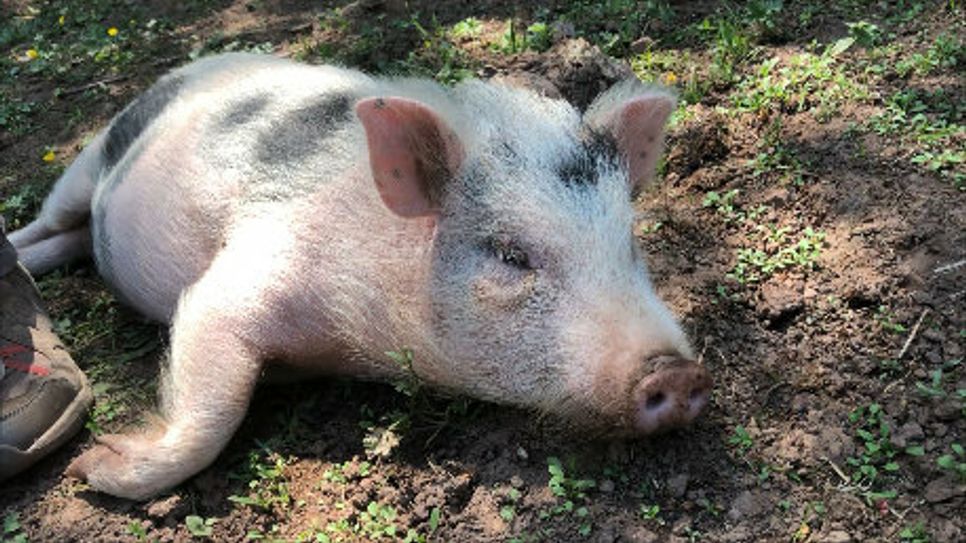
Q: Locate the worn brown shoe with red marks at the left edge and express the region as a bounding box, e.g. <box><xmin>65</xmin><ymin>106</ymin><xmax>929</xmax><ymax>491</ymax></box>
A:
<box><xmin>0</xmin><ymin>230</ymin><xmax>94</xmax><ymax>481</ymax></box>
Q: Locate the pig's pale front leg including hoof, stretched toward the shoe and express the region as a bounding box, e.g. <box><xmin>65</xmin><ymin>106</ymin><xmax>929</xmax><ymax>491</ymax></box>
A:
<box><xmin>67</xmin><ymin>223</ymin><xmax>294</xmax><ymax>500</ymax></box>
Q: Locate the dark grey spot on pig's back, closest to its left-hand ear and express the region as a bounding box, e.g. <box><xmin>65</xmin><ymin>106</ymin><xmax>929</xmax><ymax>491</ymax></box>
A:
<box><xmin>255</xmin><ymin>94</ymin><xmax>354</xmax><ymax>164</ymax></box>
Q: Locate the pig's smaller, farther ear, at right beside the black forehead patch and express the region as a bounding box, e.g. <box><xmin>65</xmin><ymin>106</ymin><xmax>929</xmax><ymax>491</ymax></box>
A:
<box><xmin>585</xmin><ymin>83</ymin><xmax>675</xmax><ymax>192</ymax></box>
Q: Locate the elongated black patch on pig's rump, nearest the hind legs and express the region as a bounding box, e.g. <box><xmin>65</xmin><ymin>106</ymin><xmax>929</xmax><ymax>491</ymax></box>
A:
<box><xmin>103</xmin><ymin>75</ymin><xmax>184</xmax><ymax>168</ymax></box>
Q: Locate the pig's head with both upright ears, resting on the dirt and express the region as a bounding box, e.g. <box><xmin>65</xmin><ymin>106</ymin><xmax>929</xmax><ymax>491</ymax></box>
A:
<box><xmin>356</xmin><ymin>81</ymin><xmax>711</xmax><ymax>434</ymax></box>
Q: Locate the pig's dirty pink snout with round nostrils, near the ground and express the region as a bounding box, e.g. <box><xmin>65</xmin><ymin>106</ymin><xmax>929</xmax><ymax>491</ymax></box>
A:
<box><xmin>632</xmin><ymin>356</ymin><xmax>711</xmax><ymax>434</ymax></box>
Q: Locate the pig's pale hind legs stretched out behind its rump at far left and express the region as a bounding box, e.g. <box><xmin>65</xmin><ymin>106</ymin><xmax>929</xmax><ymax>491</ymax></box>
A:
<box><xmin>9</xmin><ymin>133</ymin><xmax>104</xmax><ymax>274</ymax></box>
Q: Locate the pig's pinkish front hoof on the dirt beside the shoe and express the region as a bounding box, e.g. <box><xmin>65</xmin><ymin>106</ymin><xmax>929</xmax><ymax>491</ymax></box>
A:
<box><xmin>65</xmin><ymin>435</ymin><xmax>162</xmax><ymax>500</ymax></box>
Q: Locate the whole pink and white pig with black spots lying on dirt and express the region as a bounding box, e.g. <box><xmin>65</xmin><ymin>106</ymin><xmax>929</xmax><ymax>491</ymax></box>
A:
<box><xmin>10</xmin><ymin>54</ymin><xmax>711</xmax><ymax>500</ymax></box>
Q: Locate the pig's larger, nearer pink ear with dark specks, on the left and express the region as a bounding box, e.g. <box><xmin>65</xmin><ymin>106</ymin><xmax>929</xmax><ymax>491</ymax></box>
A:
<box><xmin>356</xmin><ymin>97</ymin><xmax>463</xmax><ymax>217</ymax></box>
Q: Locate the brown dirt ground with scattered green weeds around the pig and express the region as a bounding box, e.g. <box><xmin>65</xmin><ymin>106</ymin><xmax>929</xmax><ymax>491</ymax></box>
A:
<box><xmin>0</xmin><ymin>0</ymin><xmax>966</xmax><ymax>543</ymax></box>
